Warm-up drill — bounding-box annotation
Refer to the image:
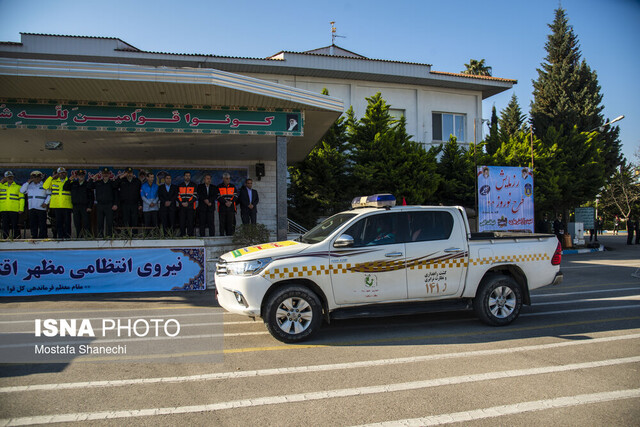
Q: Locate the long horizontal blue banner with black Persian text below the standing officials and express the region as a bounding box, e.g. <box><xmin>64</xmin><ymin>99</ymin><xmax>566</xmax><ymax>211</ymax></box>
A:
<box><xmin>0</xmin><ymin>248</ymin><xmax>206</xmax><ymax>296</ymax></box>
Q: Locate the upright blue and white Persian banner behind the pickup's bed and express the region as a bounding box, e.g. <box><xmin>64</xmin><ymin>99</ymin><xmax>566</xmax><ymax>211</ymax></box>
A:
<box><xmin>478</xmin><ymin>166</ymin><xmax>534</xmax><ymax>233</ymax></box>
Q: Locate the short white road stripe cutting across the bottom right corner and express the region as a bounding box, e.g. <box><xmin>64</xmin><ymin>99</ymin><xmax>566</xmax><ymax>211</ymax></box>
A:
<box><xmin>361</xmin><ymin>388</ymin><xmax>640</xmax><ymax>427</ymax></box>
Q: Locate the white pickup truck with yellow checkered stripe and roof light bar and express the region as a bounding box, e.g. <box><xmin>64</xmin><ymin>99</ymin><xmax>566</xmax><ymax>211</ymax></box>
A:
<box><xmin>215</xmin><ymin>195</ymin><xmax>563</xmax><ymax>343</ymax></box>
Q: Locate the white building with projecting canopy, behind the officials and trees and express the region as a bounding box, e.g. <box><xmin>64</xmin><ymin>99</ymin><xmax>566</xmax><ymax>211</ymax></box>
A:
<box><xmin>0</xmin><ymin>33</ymin><xmax>516</xmax><ymax>238</ymax></box>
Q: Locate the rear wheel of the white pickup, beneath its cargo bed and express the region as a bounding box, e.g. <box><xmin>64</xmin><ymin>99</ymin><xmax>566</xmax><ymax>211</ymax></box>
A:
<box><xmin>473</xmin><ymin>275</ymin><xmax>522</xmax><ymax>326</ymax></box>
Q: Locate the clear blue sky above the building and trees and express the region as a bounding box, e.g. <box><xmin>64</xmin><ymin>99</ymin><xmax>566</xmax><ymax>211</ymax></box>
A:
<box><xmin>0</xmin><ymin>0</ymin><xmax>640</xmax><ymax>163</ymax></box>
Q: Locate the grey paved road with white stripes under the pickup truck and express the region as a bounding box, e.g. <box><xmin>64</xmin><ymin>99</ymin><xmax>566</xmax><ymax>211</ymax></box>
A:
<box><xmin>0</xmin><ymin>236</ymin><xmax>640</xmax><ymax>426</ymax></box>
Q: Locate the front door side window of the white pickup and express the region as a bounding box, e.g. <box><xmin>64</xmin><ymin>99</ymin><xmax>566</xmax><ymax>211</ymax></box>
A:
<box><xmin>345</xmin><ymin>213</ymin><xmax>406</xmax><ymax>247</ymax></box>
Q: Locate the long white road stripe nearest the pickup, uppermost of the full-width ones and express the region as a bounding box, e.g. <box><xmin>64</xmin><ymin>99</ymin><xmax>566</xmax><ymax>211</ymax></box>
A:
<box><xmin>0</xmin><ymin>333</ymin><xmax>640</xmax><ymax>393</ymax></box>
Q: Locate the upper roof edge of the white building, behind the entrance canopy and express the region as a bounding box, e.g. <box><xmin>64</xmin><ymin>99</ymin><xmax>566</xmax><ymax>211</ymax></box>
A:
<box><xmin>0</xmin><ymin>33</ymin><xmax>517</xmax><ymax>99</ymax></box>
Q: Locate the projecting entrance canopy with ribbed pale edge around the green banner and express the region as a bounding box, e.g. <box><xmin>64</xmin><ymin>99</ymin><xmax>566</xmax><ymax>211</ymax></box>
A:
<box><xmin>0</xmin><ymin>56</ymin><xmax>344</xmax><ymax>165</ymax></box>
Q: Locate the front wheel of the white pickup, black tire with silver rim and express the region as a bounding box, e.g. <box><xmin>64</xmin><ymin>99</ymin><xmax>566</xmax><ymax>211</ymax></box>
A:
<box><xmin>264</xmin><ymin>285</ymin><xmax>322</xmax><ymax>343</ymax></box>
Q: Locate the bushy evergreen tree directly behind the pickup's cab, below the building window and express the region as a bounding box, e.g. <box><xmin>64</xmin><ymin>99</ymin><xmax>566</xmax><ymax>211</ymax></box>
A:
<box><xmin>347</xmin><ymin>93</ymin><xmax>439</xmax><ymax>204</ymax></box>
